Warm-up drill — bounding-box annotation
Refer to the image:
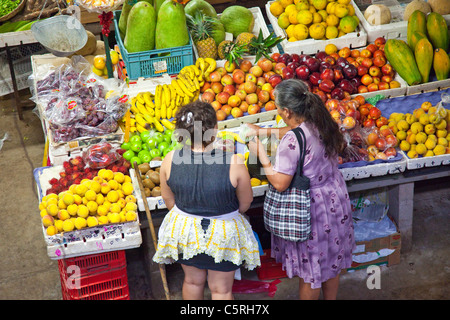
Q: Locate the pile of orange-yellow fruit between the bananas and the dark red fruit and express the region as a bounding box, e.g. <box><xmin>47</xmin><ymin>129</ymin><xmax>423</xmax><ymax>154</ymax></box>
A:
<box><xmin>201</xmin><ymin>57</ymin><xmax>282</xmax><ymax>121</ymax></box>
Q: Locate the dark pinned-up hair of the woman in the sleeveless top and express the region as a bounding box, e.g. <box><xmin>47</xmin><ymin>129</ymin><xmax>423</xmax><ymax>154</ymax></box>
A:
<box><xmin>175</xmin><ymin>100</ymin><xmax>217</xmax><ymax>147</ymax></box>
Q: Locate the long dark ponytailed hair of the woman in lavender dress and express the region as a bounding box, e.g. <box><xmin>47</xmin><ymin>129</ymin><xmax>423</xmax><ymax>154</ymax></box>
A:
<box><xmin>275</xmin><ymin>79</ymin><xmax>345</xmax><ymax>156</ymax></box>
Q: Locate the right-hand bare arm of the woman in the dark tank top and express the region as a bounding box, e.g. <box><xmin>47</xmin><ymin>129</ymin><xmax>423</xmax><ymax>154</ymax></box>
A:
<box><xmin>230</xmin><ymin>154</ymin><xmax>253</xmax><ymax>213</ymax></box>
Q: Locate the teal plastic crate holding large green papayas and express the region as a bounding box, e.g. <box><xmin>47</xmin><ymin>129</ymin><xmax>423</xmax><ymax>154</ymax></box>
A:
<box><xmin>114</xmin><ymin>10</ymin><xmax>194</xmax><ymax>80</ymax></box>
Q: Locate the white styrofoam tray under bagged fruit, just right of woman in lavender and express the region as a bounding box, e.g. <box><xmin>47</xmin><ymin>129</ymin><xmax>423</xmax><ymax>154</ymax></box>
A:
<box><xmin>339</xmin><ymin>154</ymin><xmax>407</xmax><ymax>181</ymax></box>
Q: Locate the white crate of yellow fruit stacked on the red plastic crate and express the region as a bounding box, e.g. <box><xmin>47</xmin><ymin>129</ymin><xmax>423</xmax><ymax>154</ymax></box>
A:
<box><xmin>33</xmin><ymin>166</ymin><xmax>142</xmax><ymax>260</ymax></box>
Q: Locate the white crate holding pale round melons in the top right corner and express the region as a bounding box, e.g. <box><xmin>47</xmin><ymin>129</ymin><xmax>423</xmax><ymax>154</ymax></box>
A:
<box><xmin>351</xmin><ymin>0</ymin><xmax>450</xmax><ymax>43</ymax></box>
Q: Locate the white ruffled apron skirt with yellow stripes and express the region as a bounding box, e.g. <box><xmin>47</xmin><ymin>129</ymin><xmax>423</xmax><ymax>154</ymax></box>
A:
<box><xmin>153</xmin><ymin>206</ymin><xmax>261</xmax><ymax>270</ymax></box>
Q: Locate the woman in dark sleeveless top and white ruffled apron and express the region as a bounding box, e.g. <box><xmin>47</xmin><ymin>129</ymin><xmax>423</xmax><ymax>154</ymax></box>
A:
<box><xmin>153</xmin><ymin>100</ymin><xmax>260</xmax><ymax>300</ymax></box>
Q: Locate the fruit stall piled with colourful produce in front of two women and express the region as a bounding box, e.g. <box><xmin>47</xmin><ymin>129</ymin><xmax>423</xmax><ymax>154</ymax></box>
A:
<box><xmin>6</xmin><ymin>0</ymin><xmax>450</xmax><ymax>299</ymax></box>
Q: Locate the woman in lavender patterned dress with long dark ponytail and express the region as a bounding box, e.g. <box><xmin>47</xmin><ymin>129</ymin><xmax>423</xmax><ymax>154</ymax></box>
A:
<box><xmin>249</xmin><ymin>80</ymin><xmax>355</xmax><ymax>299</ymax></box>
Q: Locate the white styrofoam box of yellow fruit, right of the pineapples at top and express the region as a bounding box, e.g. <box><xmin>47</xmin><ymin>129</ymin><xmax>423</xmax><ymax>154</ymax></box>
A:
<box><xmin>266</xmin><ymin>1</ymin><xmax>367</xmax><ymax>54</ymax></box>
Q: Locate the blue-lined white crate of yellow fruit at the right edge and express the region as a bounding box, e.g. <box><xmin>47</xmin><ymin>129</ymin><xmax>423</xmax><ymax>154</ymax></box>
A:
<box><xmin>376</xmin><ymin>88</ymin><xmax>450</xmax><ymax>170</ymax></box>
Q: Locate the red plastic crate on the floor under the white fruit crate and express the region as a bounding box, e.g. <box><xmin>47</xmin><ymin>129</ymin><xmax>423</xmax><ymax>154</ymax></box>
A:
<box><xmin>58</xmin><ymin>250</ymin><xmax>129</xmax><ymax>300</ymax></box>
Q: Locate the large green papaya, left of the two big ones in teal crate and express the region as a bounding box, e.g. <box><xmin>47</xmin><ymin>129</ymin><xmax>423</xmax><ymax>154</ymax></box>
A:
<box><xmin>124</xmin><ymin>1</ymin><xmax>156</xmax><ymax>53</ymax></box>
